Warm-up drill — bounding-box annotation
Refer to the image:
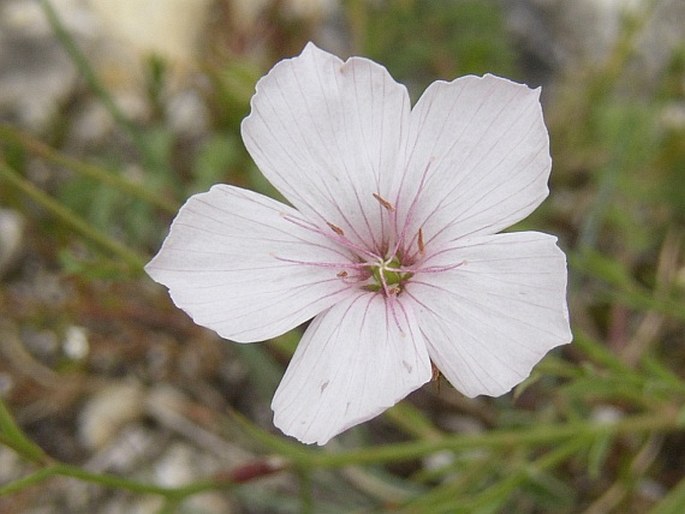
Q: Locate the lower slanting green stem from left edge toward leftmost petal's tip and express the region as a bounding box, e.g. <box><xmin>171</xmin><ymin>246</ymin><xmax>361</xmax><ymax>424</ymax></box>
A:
<box><xmin>0</xmin><ymin>160</ymin><xmax>146</xmax><ymax>271</ymax></box>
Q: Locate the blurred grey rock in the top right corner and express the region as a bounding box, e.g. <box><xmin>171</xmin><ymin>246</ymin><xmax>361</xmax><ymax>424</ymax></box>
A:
<box><xmin>502</xmin><ymin>0</ymin><xmax>685</xmax><ymax>88</ymax></box>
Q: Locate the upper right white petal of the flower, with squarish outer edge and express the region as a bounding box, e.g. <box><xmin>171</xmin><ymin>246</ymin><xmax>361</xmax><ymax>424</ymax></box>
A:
<box><xmin>398</xmin><ymin>75</ymin><xmax>551</xmax><ymax>245</ymax></box>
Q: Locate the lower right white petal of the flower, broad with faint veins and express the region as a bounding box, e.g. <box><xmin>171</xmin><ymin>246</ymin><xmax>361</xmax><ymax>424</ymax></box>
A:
<box><xmin>405</xmin><ymin>232</ymin><xmax>572</xmax><ymax>397</ymax></box>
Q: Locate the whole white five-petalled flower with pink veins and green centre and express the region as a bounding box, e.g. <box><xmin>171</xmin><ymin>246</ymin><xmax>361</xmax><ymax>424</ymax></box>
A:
<box><xmin>146</xmin><ymin>44</ymin><xmax>572</xmax><ymax>444</ymax></box>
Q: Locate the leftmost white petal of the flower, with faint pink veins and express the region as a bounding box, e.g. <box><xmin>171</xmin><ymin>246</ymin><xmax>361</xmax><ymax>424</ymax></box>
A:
<box><xmin>145</xmin><ymin>185</ymin><xmax>350</xmax><ymax>342</ymax></box>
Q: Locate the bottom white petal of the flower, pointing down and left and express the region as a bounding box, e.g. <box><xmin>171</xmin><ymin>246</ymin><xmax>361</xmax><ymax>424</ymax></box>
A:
<box><xmin>271</xmin><ymin>293</ymin><xmax>431</xmax><ymax>445</ymax></box>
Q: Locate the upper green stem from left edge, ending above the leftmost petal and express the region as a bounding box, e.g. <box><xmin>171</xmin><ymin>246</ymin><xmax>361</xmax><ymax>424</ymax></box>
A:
<box><xmin>0</xmin><ymin>124</ymin><xmax>178</xmax><ymax>214</ymax></box>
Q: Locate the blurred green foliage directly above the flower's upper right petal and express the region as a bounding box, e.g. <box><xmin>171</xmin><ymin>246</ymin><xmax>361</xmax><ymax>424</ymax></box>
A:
<box><xmin>357</xmin><ymin>0</ymin><xmax>518</xmax><ymax>95</ymax></box>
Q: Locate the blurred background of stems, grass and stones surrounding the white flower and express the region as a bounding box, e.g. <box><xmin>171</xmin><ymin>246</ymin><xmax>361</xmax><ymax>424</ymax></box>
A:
<box><xmin>0</xmin><ymin>0</ymin><xmax>685</xmax><ymax>514</ymax></box>
